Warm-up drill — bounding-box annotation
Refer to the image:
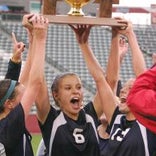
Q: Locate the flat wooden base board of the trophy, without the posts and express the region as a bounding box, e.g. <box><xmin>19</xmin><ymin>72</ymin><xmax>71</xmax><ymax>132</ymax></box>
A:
<box><xmin>44</xmin><ymin>15</ymin><xmax>127</xmax><ymax>28</ymax></box>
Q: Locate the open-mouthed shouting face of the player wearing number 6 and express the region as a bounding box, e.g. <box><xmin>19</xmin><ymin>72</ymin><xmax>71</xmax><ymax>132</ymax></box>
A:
<box><xmin>55</xmin><ymin>75</ymin><xmax>83</xmax><ymax>120</ymax></box>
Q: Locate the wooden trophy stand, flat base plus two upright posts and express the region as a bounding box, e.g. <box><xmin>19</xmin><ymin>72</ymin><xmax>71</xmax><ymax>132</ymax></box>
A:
<box><xmin>42</xmin><ymin>0</ymin><xmax>126</xmax><ymax>27</ymax></box>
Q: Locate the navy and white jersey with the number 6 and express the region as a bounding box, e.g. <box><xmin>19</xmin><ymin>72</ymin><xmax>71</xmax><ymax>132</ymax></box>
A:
<box><xmin>39</xmin><ymin>104</ymin><xmax>100</xmax><ymax>156</ymax></box>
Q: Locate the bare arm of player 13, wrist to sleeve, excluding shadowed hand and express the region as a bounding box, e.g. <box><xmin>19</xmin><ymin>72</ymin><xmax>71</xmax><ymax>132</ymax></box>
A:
<box><xmin>80</xmin><ymin>43</ymin><xmax>115</xmax><ymax>122</ymax></box>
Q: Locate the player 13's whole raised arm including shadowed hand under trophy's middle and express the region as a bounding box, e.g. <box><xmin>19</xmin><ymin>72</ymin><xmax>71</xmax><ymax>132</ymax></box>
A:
<box><xmin>71</xmin><ymin>25</ymin><xmax>116</xmax><ymax>122</ymax></box>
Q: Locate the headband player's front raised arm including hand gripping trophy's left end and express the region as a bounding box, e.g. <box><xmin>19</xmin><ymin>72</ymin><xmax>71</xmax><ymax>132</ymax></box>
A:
<box><xmin>21</xmin><ymin>15</ymin><xmax>48</xmax><ymax>119</ymax></box>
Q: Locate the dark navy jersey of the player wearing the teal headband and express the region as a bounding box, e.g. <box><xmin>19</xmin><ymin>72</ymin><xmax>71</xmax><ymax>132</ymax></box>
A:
<box><xmin>0</xmin><ymin>104</ymin><xmax>33</xmax><ymax>156</ymax></box>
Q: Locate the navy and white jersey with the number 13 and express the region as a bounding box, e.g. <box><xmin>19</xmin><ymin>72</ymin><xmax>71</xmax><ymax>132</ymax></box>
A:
<box><xmin>102</xmin><ymin>107</ymin><xmax>156</xmax><ymax>156</ymax></box>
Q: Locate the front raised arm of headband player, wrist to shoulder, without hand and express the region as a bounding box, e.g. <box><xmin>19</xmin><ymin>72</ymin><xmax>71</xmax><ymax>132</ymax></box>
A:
<box><xmin>21</xmin><ymin>29</ymin><xmax>45</xmax><ymax>116</ymax></box>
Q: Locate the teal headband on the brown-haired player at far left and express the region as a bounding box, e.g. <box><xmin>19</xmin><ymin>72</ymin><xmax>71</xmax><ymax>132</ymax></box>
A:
<box><xmin>0</xmin><ymin>80</ymin><xmax>17</xmax><ymax>106</ymax></box>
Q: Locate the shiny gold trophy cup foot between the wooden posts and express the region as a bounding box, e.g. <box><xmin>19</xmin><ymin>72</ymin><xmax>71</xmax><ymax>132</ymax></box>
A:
<box><xmin>65</xmin><ymin>0</ymin><xmax>91</xmax><ymax>16</ymax></box>
